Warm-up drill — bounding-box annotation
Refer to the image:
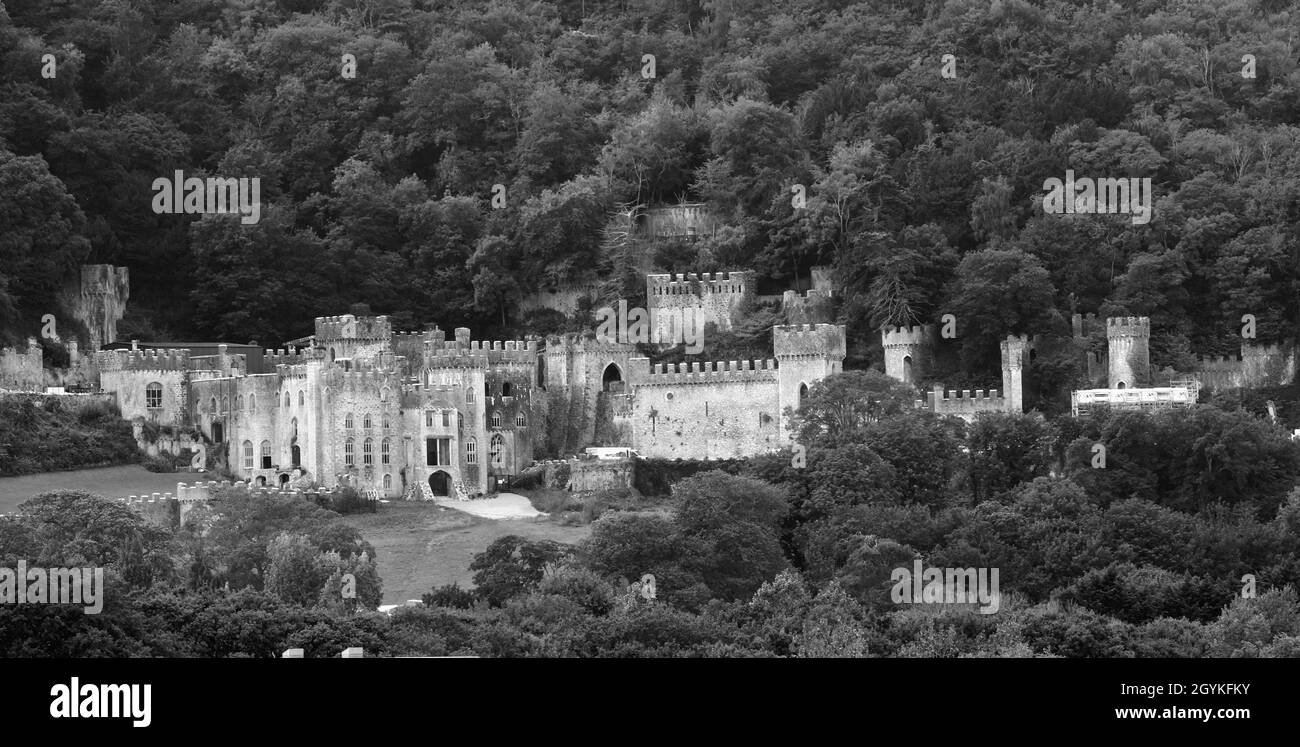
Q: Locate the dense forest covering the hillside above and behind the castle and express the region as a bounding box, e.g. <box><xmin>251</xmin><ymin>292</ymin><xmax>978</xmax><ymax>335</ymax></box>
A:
<box><xmin>0</xmin><ymin>0</ymin><xmax>1300</xmax><ymax>383</ymax></box>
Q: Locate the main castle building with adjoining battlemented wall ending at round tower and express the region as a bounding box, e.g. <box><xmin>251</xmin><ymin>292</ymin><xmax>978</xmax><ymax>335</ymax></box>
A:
<box><xmin>96</xmin><ymin>306</ymin><xmax>845</xmax><ymax>498</ymax></box>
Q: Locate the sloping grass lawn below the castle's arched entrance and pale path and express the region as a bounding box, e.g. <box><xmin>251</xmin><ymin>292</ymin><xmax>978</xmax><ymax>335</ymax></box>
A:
<box><xmin>343</xmin><ymin>501</ymin><xmax>592</xmax><ymax>604</ymax></box>
